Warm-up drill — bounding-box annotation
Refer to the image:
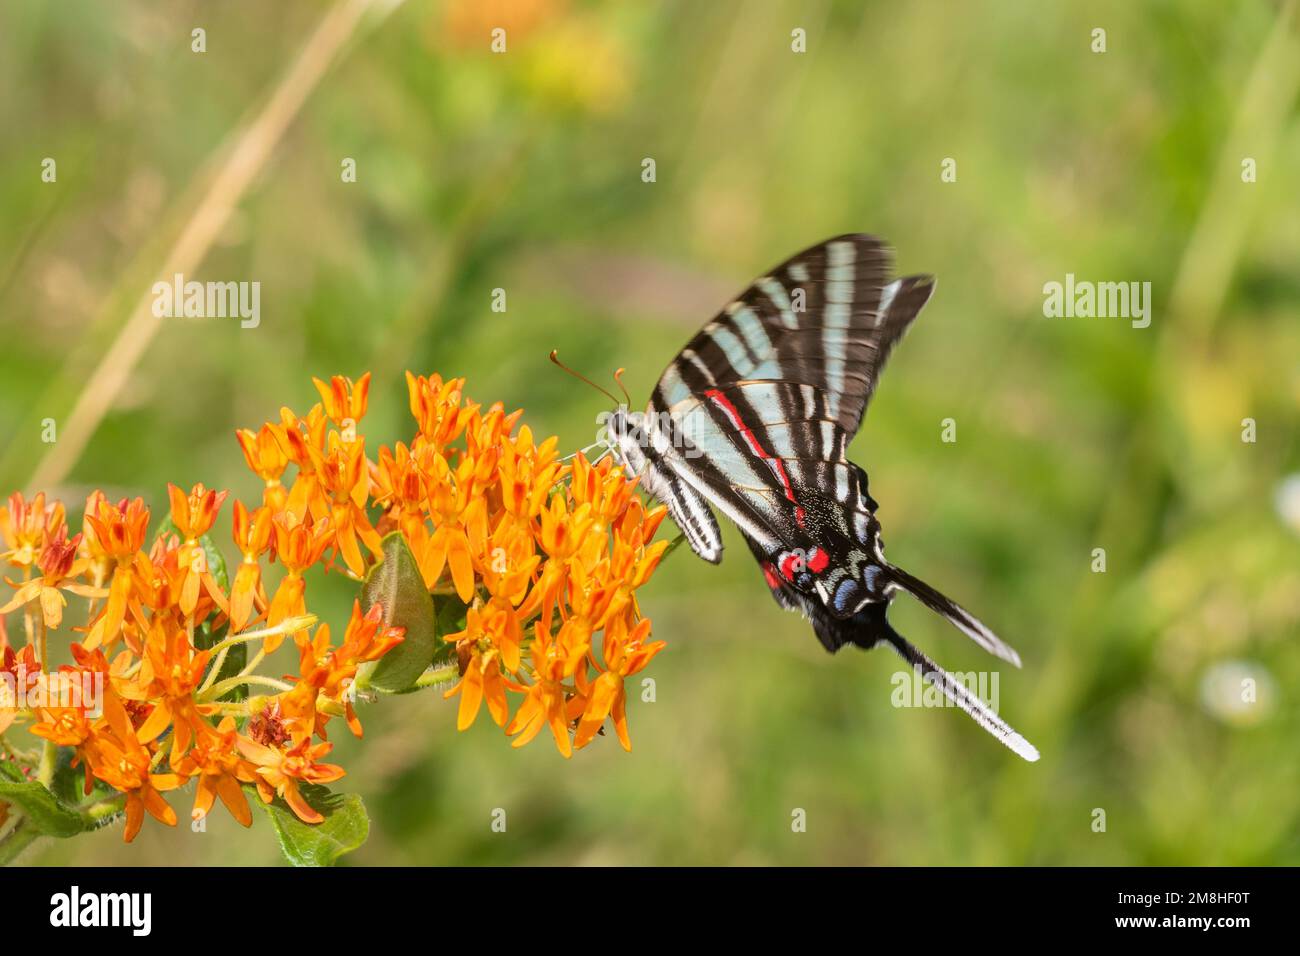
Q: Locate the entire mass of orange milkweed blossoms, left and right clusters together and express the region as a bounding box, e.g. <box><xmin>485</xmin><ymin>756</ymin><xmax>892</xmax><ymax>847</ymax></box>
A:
<box><xmin>0</xmin><ymin>373</ymin><xmax>667</xmax><ymax>840</ymax></box>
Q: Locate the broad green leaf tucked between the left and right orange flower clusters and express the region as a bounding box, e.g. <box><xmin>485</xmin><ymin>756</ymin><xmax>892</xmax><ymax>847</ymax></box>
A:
<box><xmin>361</xmin><ymin>532</ymin><xmax>441</xmax><ymax>693</ymax></box>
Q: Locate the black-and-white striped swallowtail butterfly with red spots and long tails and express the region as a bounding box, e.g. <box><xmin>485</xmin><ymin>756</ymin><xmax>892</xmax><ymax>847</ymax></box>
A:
<box><xmin>605</xmin><ymin>235</ymin><xmax>1039</xmax><ymax>761</ymax></box>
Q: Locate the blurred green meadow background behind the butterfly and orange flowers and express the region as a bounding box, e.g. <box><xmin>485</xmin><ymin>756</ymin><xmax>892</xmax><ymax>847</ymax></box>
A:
<box><xmin>0</xmin><ymin>0</ymin><xmax>1300</xmax><ymax>865</ymax></box>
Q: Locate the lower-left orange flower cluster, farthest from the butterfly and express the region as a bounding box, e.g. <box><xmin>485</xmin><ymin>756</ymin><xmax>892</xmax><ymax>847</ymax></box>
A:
<box><xmin>0</xmin><ymin>485</ymin><xmax>402</xmax><ymax>840</ymax></box>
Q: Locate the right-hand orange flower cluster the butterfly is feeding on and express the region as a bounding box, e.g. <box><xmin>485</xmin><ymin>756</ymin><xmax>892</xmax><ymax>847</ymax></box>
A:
<box><xmin>374</xmin><ymin>373</ymin><xmax>668</xmax><ymax>757</ymax></box>
